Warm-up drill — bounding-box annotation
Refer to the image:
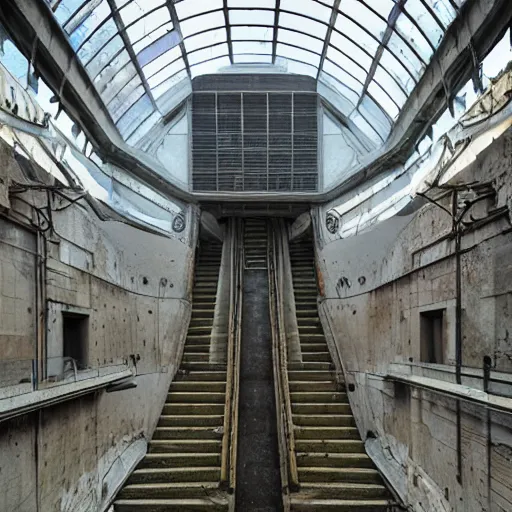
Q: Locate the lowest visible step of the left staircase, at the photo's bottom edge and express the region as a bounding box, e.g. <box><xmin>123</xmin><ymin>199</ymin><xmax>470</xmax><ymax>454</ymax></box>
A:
<box><xmin>114</xmin><ymin>498</ymin><xmax>228</xmax><ymax>512</ymax></box>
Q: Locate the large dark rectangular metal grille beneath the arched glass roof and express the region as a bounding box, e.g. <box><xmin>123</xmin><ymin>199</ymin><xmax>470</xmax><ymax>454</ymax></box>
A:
<box><xmin>192</xmin><ymin>92</ymin><xmax>318</xmax><ymax>192</ymax></box>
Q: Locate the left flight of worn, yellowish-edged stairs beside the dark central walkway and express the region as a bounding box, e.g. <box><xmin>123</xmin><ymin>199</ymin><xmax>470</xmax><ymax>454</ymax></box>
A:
<box><xmin>114</xmin><ymin>243</ymin><xmax>228</xmax><ymax>512</ymax></box>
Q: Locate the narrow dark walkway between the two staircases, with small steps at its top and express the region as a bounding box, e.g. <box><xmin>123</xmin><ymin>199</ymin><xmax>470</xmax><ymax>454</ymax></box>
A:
<box><xmin>236</xmin><ymin>220</ymin><xmax>282</xmax><ymax>512</ymax></box>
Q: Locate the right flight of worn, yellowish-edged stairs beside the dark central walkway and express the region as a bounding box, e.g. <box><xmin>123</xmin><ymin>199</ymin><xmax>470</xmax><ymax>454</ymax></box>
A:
<box><xmin>288</xmin><ymin>241</ymin><xmax>392</xmax><ymax>512</ymax></box>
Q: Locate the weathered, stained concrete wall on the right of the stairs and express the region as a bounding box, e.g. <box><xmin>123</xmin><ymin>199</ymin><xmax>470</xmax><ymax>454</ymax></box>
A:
<box><xmin>316</xmin><ymin>131</ymin><xmax>512</xmax><ymax>512</ymax></box>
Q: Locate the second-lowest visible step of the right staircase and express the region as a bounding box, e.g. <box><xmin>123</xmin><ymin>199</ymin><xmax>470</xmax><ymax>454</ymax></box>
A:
<box><xmin>294</xmin><ymin>482</ymin><xmax>389</xmax><ymax>500</ymax></box>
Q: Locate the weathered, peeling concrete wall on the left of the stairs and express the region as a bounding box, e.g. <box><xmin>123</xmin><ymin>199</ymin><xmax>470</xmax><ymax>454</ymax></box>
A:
<box><xmin>0</xmin><ymin>150</ymin><xmax>197</xmax><ymax>512</ymax></box>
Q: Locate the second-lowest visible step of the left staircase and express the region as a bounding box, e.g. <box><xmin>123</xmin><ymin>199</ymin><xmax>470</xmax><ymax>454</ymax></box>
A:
<box><xmin>119</xmin><ymin>482</ymin><xmax>218</xmax><ymax>500</ymax></box>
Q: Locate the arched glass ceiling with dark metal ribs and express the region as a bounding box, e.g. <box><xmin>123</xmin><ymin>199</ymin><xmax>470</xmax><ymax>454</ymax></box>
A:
<box><xmin>46</xmin><ymin>0</ymin><xmax>465</xmax><ymax>145</ymax></box>
